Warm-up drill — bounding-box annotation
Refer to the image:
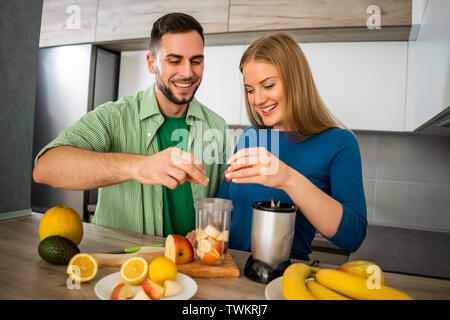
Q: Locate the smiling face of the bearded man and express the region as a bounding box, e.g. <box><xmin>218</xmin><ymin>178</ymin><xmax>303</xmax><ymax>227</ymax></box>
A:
<box><xmin>147</xmin><ymin>31</ymin><xmax>204</xmax><ymax>116</ymax></box>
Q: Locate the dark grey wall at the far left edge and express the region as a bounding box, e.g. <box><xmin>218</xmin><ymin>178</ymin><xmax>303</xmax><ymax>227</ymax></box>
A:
<box><xmin>0</xmin><ymin>0</ymin><xmax>42</xmax><ymax>219</ymax></box>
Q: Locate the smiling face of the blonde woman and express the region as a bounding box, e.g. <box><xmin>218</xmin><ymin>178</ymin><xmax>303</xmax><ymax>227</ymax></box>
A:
<box><xmin>242</xmin><ymin>60</ymin><xmax>286</xmax><ymax>130</ymax></box>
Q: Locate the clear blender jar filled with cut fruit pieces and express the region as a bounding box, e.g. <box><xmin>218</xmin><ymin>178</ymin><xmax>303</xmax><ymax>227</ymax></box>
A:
<box><xmin>194</xmin><ymin>198</ymin><xmax>233</xmax><ymax>265</ymax></box>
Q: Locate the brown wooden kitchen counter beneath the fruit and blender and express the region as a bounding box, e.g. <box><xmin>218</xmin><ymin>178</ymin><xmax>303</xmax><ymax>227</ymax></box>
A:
<box><xmin>0</xmin><ymin>214</ymin><xmax>450</xmax><ymax>300</ymax></box>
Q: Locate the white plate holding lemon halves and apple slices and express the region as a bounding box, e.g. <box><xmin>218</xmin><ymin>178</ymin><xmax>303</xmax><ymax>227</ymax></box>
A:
<box><xmin>95</xmin><ymin>272</ymin><xmax>197</xmax><ymax>300</ymax></box>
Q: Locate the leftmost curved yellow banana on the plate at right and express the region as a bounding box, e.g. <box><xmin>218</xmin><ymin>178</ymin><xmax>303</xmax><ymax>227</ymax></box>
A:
<box><xmin>281</xmin><ymin>263</ymin><xmax>318</xmax><ymax>300</ymax></box>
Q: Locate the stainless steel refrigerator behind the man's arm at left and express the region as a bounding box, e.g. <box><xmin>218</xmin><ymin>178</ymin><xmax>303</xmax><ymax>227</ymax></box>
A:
<box><xmin>31</xmin><ymin>44</ymin><xmax>120</xmax><ymax>221</ymax></box>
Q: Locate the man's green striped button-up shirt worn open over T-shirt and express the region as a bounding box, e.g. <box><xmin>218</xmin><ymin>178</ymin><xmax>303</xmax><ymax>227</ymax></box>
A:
<box><xmin>35</xmin><ymin>85</ymin><xmax>228</xmax><ymax>236</ymax></box>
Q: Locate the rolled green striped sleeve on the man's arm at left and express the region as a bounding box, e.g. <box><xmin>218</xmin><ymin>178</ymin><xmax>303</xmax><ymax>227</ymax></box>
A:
<box><xmin>34</xmin><ymin>102</ymin><xmax>118</xmax><ymax>165</ymax></box>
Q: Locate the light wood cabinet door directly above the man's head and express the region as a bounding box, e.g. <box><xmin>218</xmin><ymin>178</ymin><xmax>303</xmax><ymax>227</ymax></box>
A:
<box><xmin>96</xmin><ymin>0</ymin><xmax>228</xmax><ymax>42</ymax></box>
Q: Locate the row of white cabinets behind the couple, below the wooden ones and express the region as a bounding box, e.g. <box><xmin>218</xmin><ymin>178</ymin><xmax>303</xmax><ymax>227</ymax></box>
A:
<box><xmin>119</xmin><ymin>41</ymin><xmax>407</xmax><ymax>132</ymax></box>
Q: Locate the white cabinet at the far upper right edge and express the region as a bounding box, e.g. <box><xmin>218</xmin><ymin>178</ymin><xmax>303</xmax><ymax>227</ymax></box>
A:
<box><xmin>405</xmin><ymin>0</ymin><xmax>450</xmax><ymax>131</ymax></box>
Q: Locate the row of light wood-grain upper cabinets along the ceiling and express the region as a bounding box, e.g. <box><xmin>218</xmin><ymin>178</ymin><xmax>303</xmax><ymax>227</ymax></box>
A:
<box><xmin>40</xmin><ymin>0</ymin><xmax>412</xmax><ymax>51</ymax></box>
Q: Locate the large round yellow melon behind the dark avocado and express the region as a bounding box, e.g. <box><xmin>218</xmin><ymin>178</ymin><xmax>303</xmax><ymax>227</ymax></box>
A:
<box><xmin>39</xmin><ymin>206</ymin><xmax>83</xmax><ymax>245</ymax></box>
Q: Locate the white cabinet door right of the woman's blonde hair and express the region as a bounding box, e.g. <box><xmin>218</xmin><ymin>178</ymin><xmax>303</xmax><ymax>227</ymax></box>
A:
<box><xmin>300</xmin><ymin>42</ymin><xmax>407</xmax><ymax>131</ymax></box>
